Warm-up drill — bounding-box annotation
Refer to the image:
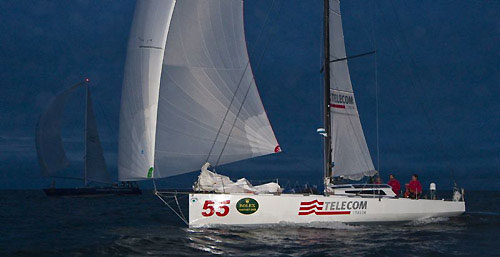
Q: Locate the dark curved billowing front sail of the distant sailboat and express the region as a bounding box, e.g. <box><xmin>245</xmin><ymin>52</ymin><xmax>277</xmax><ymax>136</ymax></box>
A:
<box><xmin>35</xmin><ymin>83</ymin><xmax>83</xmax><ymax>179</ymax></box>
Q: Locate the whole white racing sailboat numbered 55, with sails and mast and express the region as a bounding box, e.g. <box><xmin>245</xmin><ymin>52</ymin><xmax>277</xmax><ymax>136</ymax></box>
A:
<box><xmin>118</xmin><ymin>0</ymin><xmax>465</xmax><ymax>224</ymax></box>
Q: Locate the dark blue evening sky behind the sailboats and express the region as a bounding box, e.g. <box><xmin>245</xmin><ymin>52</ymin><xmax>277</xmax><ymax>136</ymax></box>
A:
<box><xmin>0</xmin><ymin>0</ymin><xmax>500</xmax><ymax>190</ymax></box>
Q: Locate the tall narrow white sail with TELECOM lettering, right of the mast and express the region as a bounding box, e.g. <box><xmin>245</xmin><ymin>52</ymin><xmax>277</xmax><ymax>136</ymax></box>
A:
<box><xmin>330</xmin><ymin>0</ymin><xmax>376</xmax><ymax>180</ymax></box>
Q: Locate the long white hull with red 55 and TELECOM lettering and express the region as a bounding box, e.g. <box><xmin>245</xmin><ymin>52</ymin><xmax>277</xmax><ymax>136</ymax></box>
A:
<box><xmin>189</xmin><ymin>193</ymin><xmax>465</xmax><ymax>227</ymax></box>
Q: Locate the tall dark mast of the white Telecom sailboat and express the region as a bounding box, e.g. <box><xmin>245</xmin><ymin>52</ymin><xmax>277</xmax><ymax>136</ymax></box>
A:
<box><xmin>323</xmin><ymin>0</ymin><xmax>332</xmax><ymax>184</ymax></box>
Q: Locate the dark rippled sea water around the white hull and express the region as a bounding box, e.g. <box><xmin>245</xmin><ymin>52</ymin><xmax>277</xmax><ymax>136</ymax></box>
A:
<box><xmin>0</xmin><ymin>191</ymin><xmax>500</xmax><ymax>256</ymax></box>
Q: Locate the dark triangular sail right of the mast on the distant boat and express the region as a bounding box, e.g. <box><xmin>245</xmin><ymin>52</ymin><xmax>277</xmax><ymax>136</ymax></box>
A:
<box><xmin>85</xmin><ymin>85</ymin><xmax>111</xmax><ymax>183</ymax></box>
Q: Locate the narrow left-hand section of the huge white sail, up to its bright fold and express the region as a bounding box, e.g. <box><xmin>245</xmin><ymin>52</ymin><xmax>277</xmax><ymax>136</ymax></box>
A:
<box><xmin>118</xmin><ymin>0</ymin><xmax>175</xmax><ymax>180</ymax></box>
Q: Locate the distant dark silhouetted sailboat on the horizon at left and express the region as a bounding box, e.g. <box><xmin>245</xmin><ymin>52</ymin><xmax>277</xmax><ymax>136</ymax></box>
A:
<box><xmin>36</xmin><ymin>78</ymin><xmax>141</xmax><ymax>196</ymax></box>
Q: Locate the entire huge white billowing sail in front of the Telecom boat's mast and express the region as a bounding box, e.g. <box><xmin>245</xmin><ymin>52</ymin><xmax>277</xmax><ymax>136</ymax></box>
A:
<box><xmin>118</xmin><ymin>0</ymin><xmax>280</xmax><ymax>180</ymax></box>
